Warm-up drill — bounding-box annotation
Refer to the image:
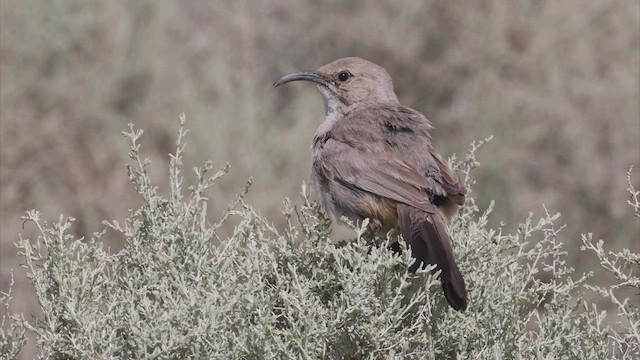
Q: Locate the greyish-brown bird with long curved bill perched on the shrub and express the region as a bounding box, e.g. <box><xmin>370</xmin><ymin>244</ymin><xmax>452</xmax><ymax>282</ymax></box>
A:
<box><xmin>273</xmin><ymin>57</ymin><xmax>467</xmax><ymax>311</ymax></box>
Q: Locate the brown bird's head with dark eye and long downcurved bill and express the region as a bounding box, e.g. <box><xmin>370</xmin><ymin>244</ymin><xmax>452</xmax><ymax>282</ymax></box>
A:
<box><xmin>273</xmin><ymin>57</ymin><xmax>398</xmax><ymax>114</ymax></box>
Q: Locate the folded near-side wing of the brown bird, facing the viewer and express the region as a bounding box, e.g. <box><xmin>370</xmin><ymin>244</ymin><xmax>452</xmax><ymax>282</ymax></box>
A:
<box><xmin>321</xmin><ymin>139</ymin><xmax>437</xmax><ymax>213</ymax></box>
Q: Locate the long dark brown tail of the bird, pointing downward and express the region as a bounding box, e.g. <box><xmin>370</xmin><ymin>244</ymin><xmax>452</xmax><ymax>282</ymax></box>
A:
<box><xmin>398</xmin><ymin>204</ymin><xmax>468</xmax><ymax>311</ymax></box>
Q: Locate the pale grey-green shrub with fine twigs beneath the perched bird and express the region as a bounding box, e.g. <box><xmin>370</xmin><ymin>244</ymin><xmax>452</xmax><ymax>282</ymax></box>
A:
<box><xmin>0</xmin><ymin>116</ymin><xmax>640</xmax><ymax>359</ymax></box>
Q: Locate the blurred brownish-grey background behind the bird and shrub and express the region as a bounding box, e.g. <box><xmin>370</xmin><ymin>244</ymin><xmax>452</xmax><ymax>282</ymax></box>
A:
<box><xmin>0</xmin><ymin>0</ymin><xmax>640</xmax><ymax>356</ymax></box>
